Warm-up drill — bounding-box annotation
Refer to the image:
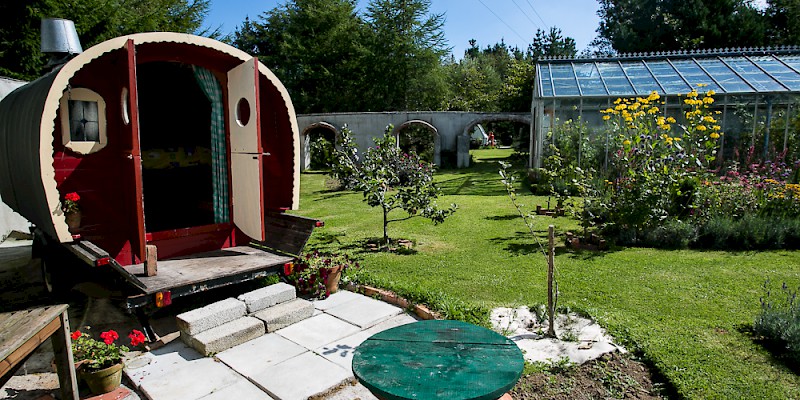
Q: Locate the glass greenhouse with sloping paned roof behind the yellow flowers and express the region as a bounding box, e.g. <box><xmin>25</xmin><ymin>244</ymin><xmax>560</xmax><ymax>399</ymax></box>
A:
<box><xmin>529</xmin><ymin>47</ymin><xmax>800</xmax><ymax>168</ymax></box>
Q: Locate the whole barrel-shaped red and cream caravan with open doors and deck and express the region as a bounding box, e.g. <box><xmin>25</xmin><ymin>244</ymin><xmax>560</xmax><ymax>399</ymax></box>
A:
<box><xmin>0</xmin><ymin>32</ymin><xmax>315</xmax><ymax>332</ymax></box>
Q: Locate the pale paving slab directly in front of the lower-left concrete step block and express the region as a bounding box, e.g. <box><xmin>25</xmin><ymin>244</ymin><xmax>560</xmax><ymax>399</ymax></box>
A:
<box><xmin>217</xmin><ymin>333</ymin><xmax>308</xmax><ymax>378</ymax></box>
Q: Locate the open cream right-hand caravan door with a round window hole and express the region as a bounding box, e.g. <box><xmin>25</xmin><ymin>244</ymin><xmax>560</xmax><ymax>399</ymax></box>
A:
<box><xmin>228</xmin><ymin>57</ymin><xmax>266</xmax><ymax>241</ymax></box>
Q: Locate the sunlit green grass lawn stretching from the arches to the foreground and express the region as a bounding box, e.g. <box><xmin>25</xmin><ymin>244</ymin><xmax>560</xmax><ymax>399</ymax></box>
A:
<box><xmin>297</xmin><ymin>150</ymin><xmax>800</xmax><ymax>399</ymax></box>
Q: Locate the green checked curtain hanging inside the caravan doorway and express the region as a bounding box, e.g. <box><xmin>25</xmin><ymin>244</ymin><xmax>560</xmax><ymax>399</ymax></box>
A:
<box><xmin>194</xmin><ymin>65</ymin><xmax>230</xmax><ymax>224</ymax></box>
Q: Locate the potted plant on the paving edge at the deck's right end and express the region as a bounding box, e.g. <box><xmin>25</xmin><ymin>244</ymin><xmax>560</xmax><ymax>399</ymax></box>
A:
<box><xmin>284</xmin><ymin>251</ymin><xmax>358</xmax><ymax>299</ymax></box>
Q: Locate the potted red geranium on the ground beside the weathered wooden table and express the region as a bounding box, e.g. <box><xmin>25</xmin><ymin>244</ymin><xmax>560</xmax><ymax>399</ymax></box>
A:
<box><xmin>70</xmin><ymin>329</ymin><xmax>145</xmax><ymax>394</ymax></box>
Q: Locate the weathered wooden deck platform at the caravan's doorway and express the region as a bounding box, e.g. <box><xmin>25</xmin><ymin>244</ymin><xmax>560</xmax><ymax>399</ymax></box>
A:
<box><xmin>123</xmin><ymin>246</ymin><xmax>292</xmax><ymax>294</ymax></box>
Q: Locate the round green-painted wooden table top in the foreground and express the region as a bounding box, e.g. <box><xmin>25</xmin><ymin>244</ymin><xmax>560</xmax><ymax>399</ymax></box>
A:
<box><xmin>353</xmin><ymin>320</ymin><xmax>524</xmax><ymax>400</ymax></box>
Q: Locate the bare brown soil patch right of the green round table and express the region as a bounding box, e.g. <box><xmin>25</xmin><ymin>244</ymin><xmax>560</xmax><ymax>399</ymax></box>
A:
<box><xmin>511</xmin><ymin>353</ymin><xmax>667</xmax><ymax>400</ymax></box>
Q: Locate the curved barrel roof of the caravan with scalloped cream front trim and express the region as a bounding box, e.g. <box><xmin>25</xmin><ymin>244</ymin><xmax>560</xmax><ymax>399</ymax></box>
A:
<box><xmin>0</xmin><ymin>32</ymin><xmax>300</xmax><ymax>242</ymax></box>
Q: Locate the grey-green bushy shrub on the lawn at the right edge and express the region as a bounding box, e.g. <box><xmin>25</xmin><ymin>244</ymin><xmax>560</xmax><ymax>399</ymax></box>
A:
<box><xmin>753</xmin><ymin>281</ymin><xmax>800</xmax><ymax>363</ymax></box>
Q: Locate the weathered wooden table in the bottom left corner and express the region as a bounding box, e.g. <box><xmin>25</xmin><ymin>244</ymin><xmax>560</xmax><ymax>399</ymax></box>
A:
<box><xmin>0</xmin><ymin>304</ymin><xmax>78</xmax><ymax>400</ymax></box>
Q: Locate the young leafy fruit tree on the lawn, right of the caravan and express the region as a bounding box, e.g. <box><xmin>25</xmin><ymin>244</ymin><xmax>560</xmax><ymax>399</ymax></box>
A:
<box><xmin>331</xmin><ymin>125</ymin><xmax>457</xmax><ymax>246</ymax></box>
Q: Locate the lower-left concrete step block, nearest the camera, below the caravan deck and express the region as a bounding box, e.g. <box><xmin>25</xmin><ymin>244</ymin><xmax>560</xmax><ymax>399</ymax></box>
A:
<box><xmin>181</xmin><ymin>317</ymin><xmax>265</xmax><ymax>356</ymax></box>
